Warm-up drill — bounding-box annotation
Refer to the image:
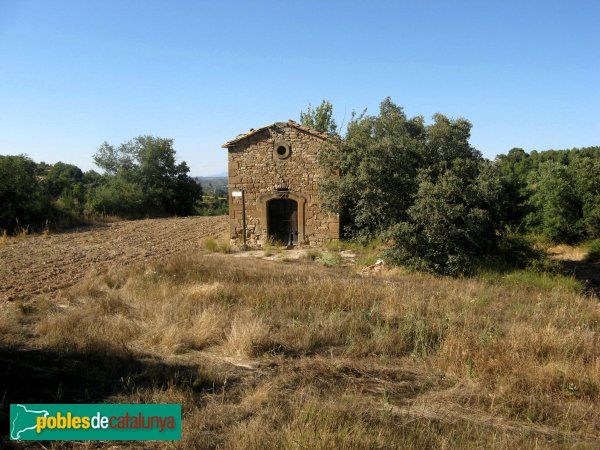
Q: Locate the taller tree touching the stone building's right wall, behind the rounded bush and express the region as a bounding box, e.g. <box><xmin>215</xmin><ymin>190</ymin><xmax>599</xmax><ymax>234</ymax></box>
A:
<box><xmin>320</xmin><ymin>98</ymin><xmax>481</xmax><ymax>241</ymax></box>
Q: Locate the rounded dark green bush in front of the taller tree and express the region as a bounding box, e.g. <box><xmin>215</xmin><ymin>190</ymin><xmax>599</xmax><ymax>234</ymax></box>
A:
<box><xmin>388</xmin><ymin>159</ymin><xmax>500</xmax><ymax>275</ymax></box>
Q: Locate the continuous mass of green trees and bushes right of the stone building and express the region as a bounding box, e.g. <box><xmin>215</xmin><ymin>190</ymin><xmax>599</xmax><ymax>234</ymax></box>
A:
<box><xmin>300</xmin><ymin>98</ymin><xmax>600</xmax><ymax>275</ymax></box>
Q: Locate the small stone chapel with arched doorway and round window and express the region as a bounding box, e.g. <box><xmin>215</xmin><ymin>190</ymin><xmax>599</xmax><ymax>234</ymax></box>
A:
<box><xmin>222</xmin><ymin>120</ymin><xmax>340</xmax><ymax>246</ymax></box>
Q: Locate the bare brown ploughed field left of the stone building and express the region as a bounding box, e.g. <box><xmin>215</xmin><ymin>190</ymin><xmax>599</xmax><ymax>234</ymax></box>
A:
<box><xmin>0</xmin><ymin>216</ymin><xmax>227</xmax><ymax>301</ymax></box>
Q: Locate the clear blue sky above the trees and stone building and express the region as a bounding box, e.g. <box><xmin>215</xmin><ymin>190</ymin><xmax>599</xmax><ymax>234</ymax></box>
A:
<box><xmin>0</xmin><ymin>0</ymin><xmax>600</xmax><ymax>175</ymax></box>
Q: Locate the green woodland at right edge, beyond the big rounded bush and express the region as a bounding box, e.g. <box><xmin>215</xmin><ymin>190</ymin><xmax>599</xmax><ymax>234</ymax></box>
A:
<box><xmin>496</xmin><ymin>147</ymin><xmax>600</xmax><ymax>243</ymax></box>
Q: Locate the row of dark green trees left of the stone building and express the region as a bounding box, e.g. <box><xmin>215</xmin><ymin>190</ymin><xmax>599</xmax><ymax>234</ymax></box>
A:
<box><xmin>0</xmin><ymin>136</ymin><xmax>202</xmax><ymax>233</ymax></box>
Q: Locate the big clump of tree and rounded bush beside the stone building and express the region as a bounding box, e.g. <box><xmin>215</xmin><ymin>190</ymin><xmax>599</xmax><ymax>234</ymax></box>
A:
<box><xmin>320</xmin><ymin>98</ymin><xmax>502</xmax><ymax>275</ymax></box>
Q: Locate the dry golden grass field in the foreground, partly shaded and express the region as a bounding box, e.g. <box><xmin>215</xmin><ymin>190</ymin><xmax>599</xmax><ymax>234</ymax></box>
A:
<box><xmin>0</xmin><ymin>244</ymin><xmax>600</xmax><ymax>449</ymax></box>
